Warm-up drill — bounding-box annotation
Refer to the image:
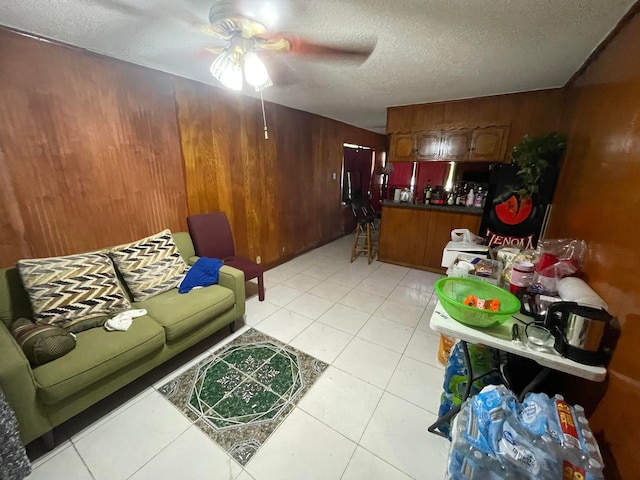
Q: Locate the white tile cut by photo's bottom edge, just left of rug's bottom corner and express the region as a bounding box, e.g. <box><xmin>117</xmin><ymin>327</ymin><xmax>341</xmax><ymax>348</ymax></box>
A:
<box><xmin>130</xmin><ymin>426</ymin><xmax>242</xmax><ymax>480</ymax></box>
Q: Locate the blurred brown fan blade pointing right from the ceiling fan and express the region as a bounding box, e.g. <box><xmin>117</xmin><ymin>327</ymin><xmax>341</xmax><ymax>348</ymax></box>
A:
<box><xmin>258</xmin><ymin>34</ymin><xmax>377</xmax><ymax>63</ymax></box>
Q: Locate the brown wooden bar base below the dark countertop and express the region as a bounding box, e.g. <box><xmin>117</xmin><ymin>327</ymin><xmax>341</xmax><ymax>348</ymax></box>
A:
<box><xmin>378</xmin><ymin>205</ymin><xmax>482</xmax><ymax>273</ymax></box>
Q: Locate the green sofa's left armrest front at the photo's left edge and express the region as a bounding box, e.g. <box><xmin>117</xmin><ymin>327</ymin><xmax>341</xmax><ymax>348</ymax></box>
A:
<box><xmin>0</xmin><ymin>322</ymin><xmax>52</xmax><ymax>444</ymax></box>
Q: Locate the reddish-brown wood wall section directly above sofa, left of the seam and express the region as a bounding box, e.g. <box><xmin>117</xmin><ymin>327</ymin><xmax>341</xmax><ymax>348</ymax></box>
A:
<box><xmin>0</xmin><ymin>29</ymin><xmax>187</xmax><ymax>266</ymax></box>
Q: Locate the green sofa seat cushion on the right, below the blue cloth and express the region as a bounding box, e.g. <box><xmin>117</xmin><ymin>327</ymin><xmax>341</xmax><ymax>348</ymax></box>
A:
<box><xmin>133</xmin><ymin>285</ymin><xmax>235</xmax><ymax>342</ymax></box>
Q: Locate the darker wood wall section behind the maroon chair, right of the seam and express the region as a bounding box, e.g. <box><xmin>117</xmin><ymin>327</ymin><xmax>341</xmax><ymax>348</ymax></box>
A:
<box><xmin>175</xmin><ymin>79</ymin><xmax>386</xmax><ymax>264</ymax></box>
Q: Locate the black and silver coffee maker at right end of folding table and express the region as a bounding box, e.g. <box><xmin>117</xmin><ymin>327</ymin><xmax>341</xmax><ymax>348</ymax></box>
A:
<box><xmin>544</xmin><ymin>302</ymin><xmax>615</xmax><ymax>365</ymax></box>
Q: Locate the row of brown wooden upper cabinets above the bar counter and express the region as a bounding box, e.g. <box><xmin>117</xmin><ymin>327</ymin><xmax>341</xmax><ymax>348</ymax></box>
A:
<box><xmin>390</xmin><ymin>126</ymin><xmax>509</xmax><ymax>162</ymax></box>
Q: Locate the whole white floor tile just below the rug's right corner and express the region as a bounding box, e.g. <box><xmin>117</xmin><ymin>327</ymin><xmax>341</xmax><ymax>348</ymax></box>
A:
<box><xmin>298</xmin><ymin>367</ymin><xmax>382</xmax><ymax>442</ymax></box>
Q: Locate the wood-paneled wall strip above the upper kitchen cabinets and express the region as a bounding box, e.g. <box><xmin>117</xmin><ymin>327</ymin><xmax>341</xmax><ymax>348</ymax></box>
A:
<box><xmin>387</xmin><ymin>88</ymin><xmax>563</xmax><ymax>156</ymax></box>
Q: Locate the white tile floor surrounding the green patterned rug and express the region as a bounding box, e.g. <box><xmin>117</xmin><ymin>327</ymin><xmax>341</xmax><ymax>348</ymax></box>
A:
<box><xmin>29</xmin><ymin>235</ymin><xmax>449</xmax><ymax>480</ymax></box>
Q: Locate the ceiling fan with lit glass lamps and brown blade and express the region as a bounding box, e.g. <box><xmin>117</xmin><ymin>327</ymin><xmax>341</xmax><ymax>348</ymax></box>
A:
<box><xmin>201</xmin><ymin>0</ymin><xmax>375</xmax><ymax>91</ymax></box>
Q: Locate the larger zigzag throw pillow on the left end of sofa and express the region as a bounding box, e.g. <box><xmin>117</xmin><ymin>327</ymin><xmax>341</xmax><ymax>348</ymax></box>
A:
<box><xmin>18</xmin><ymin>252</ymin><xmax>131</xmax><ymax>328</ymax></box>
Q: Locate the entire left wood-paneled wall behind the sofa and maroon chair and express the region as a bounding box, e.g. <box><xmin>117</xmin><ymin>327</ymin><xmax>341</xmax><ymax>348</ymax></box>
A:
<box><xmin>0</xmin><ymin>29</ymin><xmax>386</xmax><ymax>266</ymax></box>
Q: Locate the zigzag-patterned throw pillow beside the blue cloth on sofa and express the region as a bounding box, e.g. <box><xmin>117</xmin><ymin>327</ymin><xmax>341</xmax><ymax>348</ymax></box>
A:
<box><xmin>109</xmin><ymin>230</ymin><xmax>188</xmax><ymax>302</ymax></box>
